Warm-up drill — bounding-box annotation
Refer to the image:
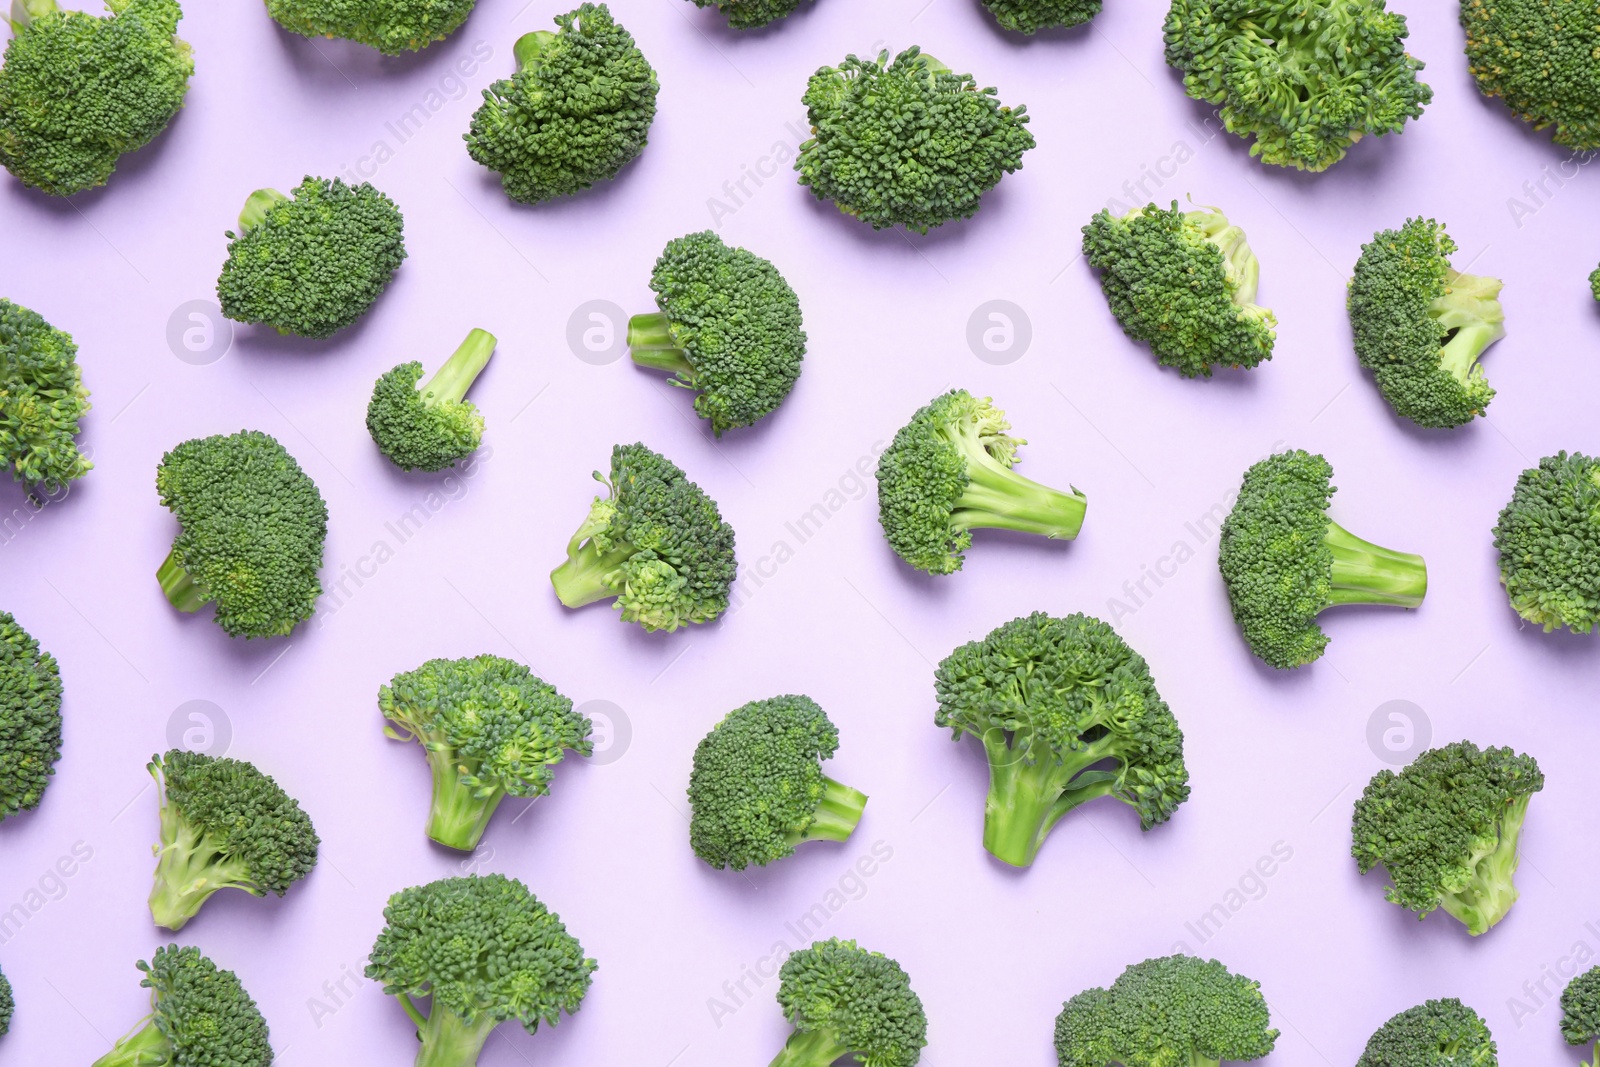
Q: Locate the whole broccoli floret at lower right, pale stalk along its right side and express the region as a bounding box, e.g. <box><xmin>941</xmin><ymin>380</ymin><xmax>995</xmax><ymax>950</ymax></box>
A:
<box><xmin>1350</xmin><ymin>741</ymin><xmax>1544</xmax><ymax>936</ymax></box>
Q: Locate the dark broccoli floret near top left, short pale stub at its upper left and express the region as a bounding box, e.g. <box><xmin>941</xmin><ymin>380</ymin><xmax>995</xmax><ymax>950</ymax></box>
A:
<box><xmin>466</xmin><ymin>3</ymin><xmax>659</xmax><ymax>203</ymax></box>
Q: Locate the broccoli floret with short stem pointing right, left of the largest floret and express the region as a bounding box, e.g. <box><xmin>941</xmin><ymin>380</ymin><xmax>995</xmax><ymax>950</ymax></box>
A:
<box><xmin>690</xmin><ymin>696</ymin><xmax>867</xmax><ymax>870</ymax></box>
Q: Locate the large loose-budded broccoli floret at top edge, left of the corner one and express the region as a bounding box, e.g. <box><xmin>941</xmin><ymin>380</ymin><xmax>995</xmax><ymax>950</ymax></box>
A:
<box><xmin>1166</xmin><ymin>0</ymin><xmax>1434</xmax><ymax>171</ymax></box>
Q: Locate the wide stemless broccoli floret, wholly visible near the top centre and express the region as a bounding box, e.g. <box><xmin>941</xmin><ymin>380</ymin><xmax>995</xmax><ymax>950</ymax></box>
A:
<box><xmin>795</xmin><ymin>46</ymin><xmax>1034</xmax><ymax>234</ymax></box>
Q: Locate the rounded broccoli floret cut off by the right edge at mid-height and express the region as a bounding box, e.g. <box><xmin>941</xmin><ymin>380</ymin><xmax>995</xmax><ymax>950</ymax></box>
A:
<box><xmin>1494</xmin><ymin>451</ymin><xmax>1600</xmax><ymax>633</ymax></box>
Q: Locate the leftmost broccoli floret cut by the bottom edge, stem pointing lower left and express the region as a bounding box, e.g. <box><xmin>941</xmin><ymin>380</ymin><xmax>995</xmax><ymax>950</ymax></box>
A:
<box><xmin>93</xmin><ymin>945</ymin><xmax>272</xmax><ymax>1067</ymax></box>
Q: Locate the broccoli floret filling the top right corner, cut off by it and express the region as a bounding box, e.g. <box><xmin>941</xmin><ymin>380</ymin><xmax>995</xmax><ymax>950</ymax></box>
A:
<box><xmin>1461</xmin><ymin>0</ymin><xmax>1600</xmax><ymax>152</ymax></box>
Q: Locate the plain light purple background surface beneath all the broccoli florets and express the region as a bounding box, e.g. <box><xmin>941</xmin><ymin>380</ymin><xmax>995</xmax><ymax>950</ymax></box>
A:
<box><xmin>0</xmin><ymin>0</ymin><xmax>1600</xmax><ymax>1067</ymax></box>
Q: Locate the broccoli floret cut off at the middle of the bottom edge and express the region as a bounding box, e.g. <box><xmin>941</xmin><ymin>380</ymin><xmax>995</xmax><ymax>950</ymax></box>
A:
<box><xmin>771</xmin><ymin>937</ymin><xmax>928</xmax><ymax>1067</ymax></box>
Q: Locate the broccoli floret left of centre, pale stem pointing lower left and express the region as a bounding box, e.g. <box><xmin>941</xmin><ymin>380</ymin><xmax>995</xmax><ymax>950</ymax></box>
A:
<box><xmin>550</xmin><ymin>443</ymin><xmax>738</xmax><ymax>632</ymax></box>
